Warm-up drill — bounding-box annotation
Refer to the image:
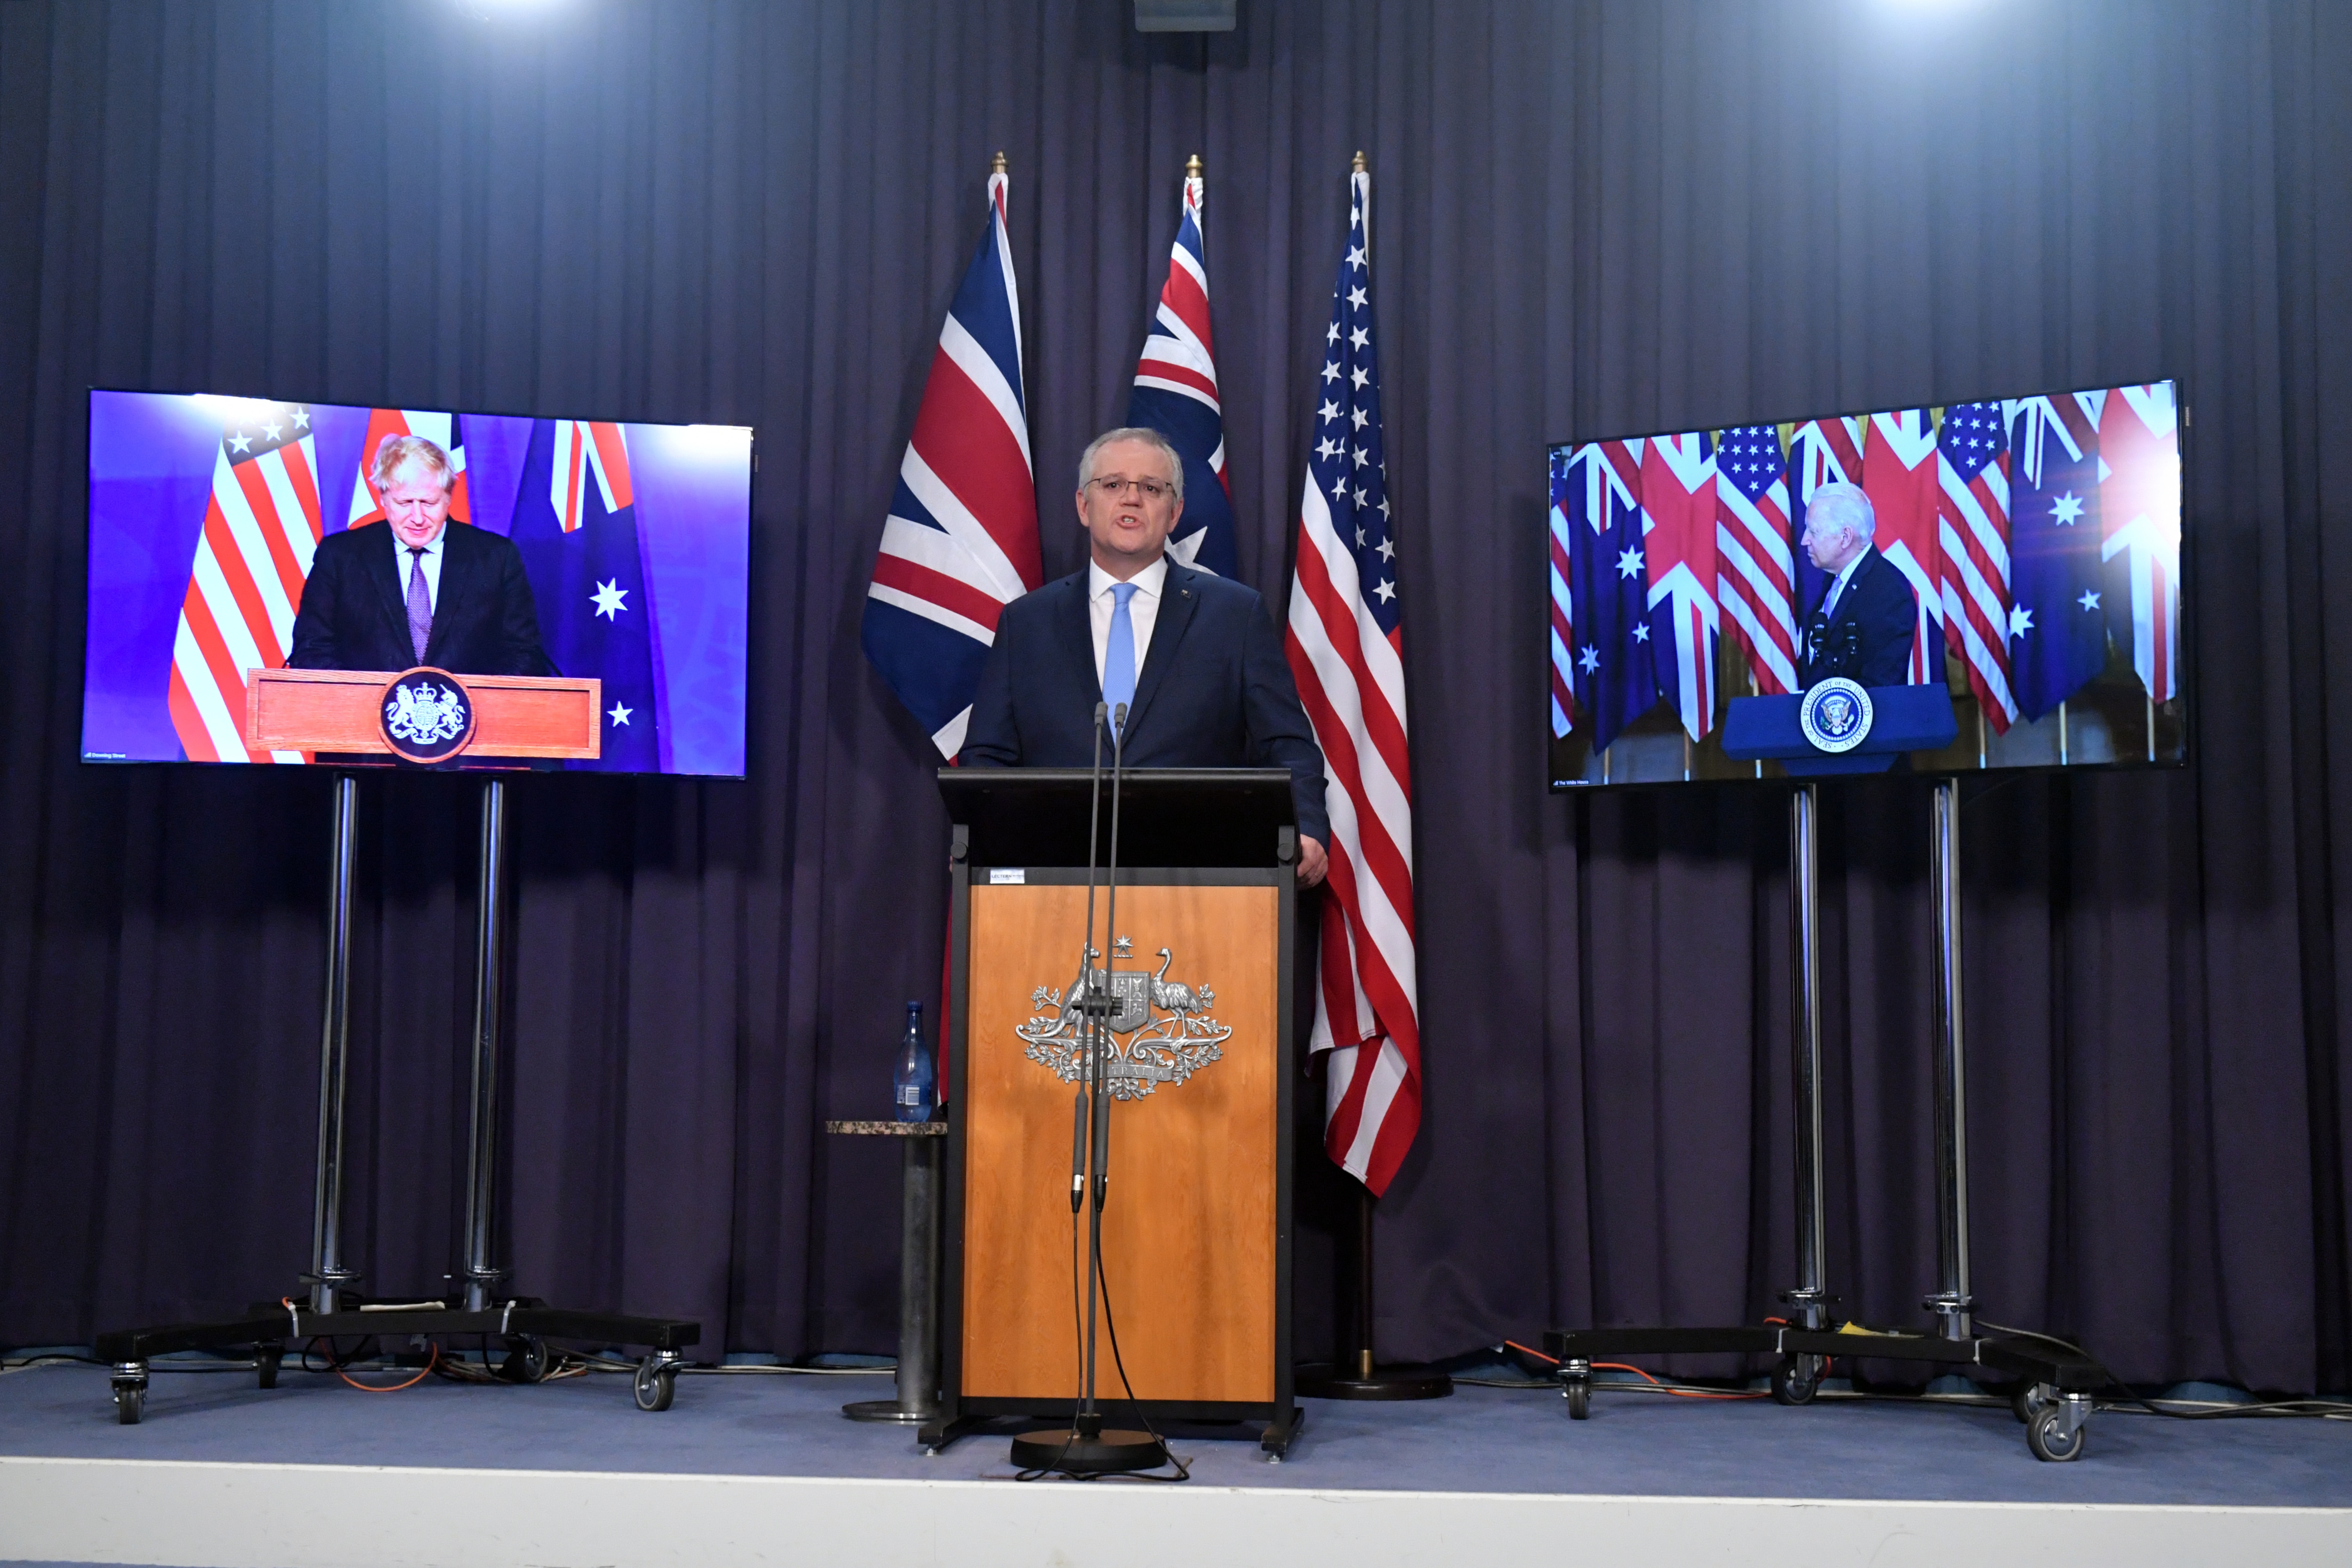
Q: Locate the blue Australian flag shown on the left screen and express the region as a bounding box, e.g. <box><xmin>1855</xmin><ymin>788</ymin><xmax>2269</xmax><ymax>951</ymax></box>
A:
<box><xmin>513</xmin><ymin>418</ymin><xmax>663</xmax><ymax>773</ymax></box>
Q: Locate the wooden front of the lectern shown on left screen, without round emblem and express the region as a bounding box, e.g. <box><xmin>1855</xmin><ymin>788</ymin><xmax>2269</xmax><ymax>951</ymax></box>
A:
<box><xmin>245</xmin><ymin>670</ymin><xmax>604</xmax><ymax>759</ymax></box>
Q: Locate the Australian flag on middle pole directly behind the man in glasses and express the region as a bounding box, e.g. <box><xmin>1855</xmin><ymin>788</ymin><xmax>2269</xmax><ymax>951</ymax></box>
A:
<box><xmin>1127</xmin><ymin>158</ymin><xmax>1240</xmax><ymax>576</ymax></box>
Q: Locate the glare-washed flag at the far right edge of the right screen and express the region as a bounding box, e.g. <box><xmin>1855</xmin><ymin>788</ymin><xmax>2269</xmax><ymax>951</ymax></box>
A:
<box><xmin>2098</xmin><ymin>381</ymin><xmax>2180</xmax><ymax>703</ymax></box>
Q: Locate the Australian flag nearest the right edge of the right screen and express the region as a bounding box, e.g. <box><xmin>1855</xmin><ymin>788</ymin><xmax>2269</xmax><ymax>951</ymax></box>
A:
<box><xmin>2009</xmin><ymin>392</ymin><xmax>2107</xmax><ymax>719</ymax></box>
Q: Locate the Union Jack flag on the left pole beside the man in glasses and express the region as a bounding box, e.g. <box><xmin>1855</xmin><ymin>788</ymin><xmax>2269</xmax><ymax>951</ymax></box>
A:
<box><xmin>863</xmin><ymin>160</ymin><xmax>1042</xmax><ymax>762</ymax></box>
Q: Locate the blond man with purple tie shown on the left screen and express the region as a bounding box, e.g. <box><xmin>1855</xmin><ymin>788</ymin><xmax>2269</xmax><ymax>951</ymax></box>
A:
<box><xmin>287</xmin><ymin>435</ymin><xmax>553</xmax><ymax>675</ymax></box>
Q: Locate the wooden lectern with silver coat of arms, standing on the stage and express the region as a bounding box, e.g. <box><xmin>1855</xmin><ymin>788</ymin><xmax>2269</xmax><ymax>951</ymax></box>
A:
<box><xmin>922</xmin><ymin>769</ymin><xmax>1298</xmax><ymax>1455</ymax></box>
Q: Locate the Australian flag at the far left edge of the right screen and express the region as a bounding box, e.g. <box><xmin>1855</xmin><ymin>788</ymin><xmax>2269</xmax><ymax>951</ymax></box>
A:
<box><xmin>1552</xmin><ymin>442</ymin><xmax>1658</xmax><ymax>752</ymax></box>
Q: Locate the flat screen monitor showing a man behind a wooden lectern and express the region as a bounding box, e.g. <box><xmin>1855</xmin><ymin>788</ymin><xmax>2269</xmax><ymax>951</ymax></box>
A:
<box><xmin>82</xmin><ymin>390</ymin><xmax>753</xmax><ymax>778</ymax></box>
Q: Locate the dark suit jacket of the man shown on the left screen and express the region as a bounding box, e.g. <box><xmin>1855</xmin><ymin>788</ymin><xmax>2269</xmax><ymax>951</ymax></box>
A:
<box><xmin>287</xmin><ymin>522</ymin><xmax>555</xmax><ymax>675</ymax></box>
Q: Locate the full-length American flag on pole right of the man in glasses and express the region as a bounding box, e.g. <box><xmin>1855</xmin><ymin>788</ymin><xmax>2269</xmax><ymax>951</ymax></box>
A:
<box><xmin>1284</xmin><ymin>169</ymin><xmax>1421</xmax><ymax>1196</ymax></box>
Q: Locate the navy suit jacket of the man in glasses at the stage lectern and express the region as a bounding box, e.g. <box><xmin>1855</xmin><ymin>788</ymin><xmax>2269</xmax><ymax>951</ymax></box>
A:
<box><xmin>960</xmin><ymin>559</ymin><xmax>1331</xmax><ymax>844</ymax></box>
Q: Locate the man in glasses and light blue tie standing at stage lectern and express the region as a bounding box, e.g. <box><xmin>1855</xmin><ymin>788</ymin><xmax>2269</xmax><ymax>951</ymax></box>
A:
<box><xmin>962</xmin><ymin>430</ymin><xmax>1331</xmax><ymax>886</ymax></box>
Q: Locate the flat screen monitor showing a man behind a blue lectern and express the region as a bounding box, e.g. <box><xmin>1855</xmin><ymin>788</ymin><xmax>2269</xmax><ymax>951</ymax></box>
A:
<box><xmin>1548</xmin><ymin>381</ymin><xmax>2187</xmax><ymax>790</ymax></box>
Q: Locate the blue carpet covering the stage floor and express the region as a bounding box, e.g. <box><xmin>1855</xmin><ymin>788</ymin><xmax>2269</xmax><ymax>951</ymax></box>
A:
<box><xmin>0</xmin><ymin>1366</ymin><xmax>2352</xmax><ymax>1507</ymax></box>
